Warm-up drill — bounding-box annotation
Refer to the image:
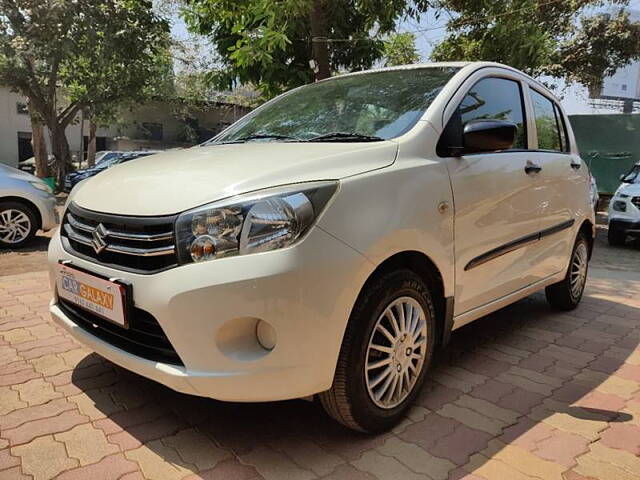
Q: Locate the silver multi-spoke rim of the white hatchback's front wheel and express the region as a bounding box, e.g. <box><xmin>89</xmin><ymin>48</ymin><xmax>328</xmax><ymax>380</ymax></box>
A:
<box><xmin>365</xmin><ymin>297</ymin><xmax>427</xmax><ymax>409</ymax></box>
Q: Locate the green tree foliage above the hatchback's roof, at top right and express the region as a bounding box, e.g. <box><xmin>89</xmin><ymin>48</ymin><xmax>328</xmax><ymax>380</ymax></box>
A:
<box><xmin>432</xmin><ymin>0</ymin><xmax>640</xmax><ymax>90</ymax></box>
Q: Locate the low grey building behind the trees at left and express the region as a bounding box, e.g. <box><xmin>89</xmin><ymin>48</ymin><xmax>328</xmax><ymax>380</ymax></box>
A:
<box><xmin>0</xmin><ymin>87</ymin><xmax>249</xmax><ymax>166</ymax></box>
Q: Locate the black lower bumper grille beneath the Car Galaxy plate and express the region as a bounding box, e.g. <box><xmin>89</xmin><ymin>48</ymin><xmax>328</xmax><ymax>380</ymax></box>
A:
<box><xmin>58</xmin><ymin>298</ymin><xmax>184</xmax><ymax>366</ymax></box>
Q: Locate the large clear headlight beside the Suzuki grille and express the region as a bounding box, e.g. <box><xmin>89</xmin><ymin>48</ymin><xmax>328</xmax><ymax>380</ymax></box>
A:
<box><xmin>171</xmin><ymin>182</ymin><xmax>338</xmax><ymax>264</ymax></box>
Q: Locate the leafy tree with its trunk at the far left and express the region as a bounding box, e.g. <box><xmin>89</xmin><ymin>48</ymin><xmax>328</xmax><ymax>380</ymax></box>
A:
<box><xmin>0</xmin><ymin>0</ymin><xmax>171</xmax><ymax>185</ymax></box>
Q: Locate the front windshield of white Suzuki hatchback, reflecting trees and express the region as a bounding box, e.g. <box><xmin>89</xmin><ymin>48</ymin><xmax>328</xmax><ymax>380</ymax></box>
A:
<box><xmin>210</xmin><ymin>67</ymin><xmax>459</xmax><ymax>143</ymax></box>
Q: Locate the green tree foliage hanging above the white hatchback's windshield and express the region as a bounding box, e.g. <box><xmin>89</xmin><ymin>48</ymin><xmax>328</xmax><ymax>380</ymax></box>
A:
<box><xmin>184</xmin><ymin>0</ymin><xmax>428</xmax><ymax>96</ymax></box>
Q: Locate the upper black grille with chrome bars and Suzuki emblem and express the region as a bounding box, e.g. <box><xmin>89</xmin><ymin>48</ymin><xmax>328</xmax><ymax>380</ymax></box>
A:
<box><xmin>61</xmin><ymin>203</ymin><xmax>178</xmax><ymax>273</ymax></box>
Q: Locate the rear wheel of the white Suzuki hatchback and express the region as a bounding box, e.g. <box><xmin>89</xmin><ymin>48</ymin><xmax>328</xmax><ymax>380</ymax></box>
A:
<box><xmin>545</xmin><ymin>233</ymin><xmax>589</xmax><ymax>310</ymax></box>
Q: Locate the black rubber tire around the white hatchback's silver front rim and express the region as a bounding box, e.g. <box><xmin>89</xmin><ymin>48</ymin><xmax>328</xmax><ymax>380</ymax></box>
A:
<box><xmin>319</xmin><ymin>269</ymin><xmax>436</xmax><ymax>433</ymax></box>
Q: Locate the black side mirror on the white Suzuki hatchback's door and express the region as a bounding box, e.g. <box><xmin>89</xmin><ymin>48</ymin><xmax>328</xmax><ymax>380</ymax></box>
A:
<box><xmin>463</xmin><ymin>119</ymin><xmax>518</xmax><ymax>153</ymax></box>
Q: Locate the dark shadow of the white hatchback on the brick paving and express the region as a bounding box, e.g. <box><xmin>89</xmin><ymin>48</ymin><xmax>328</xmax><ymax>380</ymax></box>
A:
<box><xmin>73</xmin><ymin>272</ymin><xmax>640</xmax><ymax>478</ymax></box>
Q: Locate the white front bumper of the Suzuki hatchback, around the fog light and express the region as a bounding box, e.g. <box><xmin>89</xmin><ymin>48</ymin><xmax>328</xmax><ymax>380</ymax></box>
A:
<box><xmin>49</xmin><ymin>227</ymin><xmax>373</xmax><ymax>402</ymax></box>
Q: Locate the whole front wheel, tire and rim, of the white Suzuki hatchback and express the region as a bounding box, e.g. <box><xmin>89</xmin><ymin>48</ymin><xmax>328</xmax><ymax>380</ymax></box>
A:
<box><xmin>319</xmin><ymin>270</ymin><xmax>435</xmax><ymax>433</ymax></box>
